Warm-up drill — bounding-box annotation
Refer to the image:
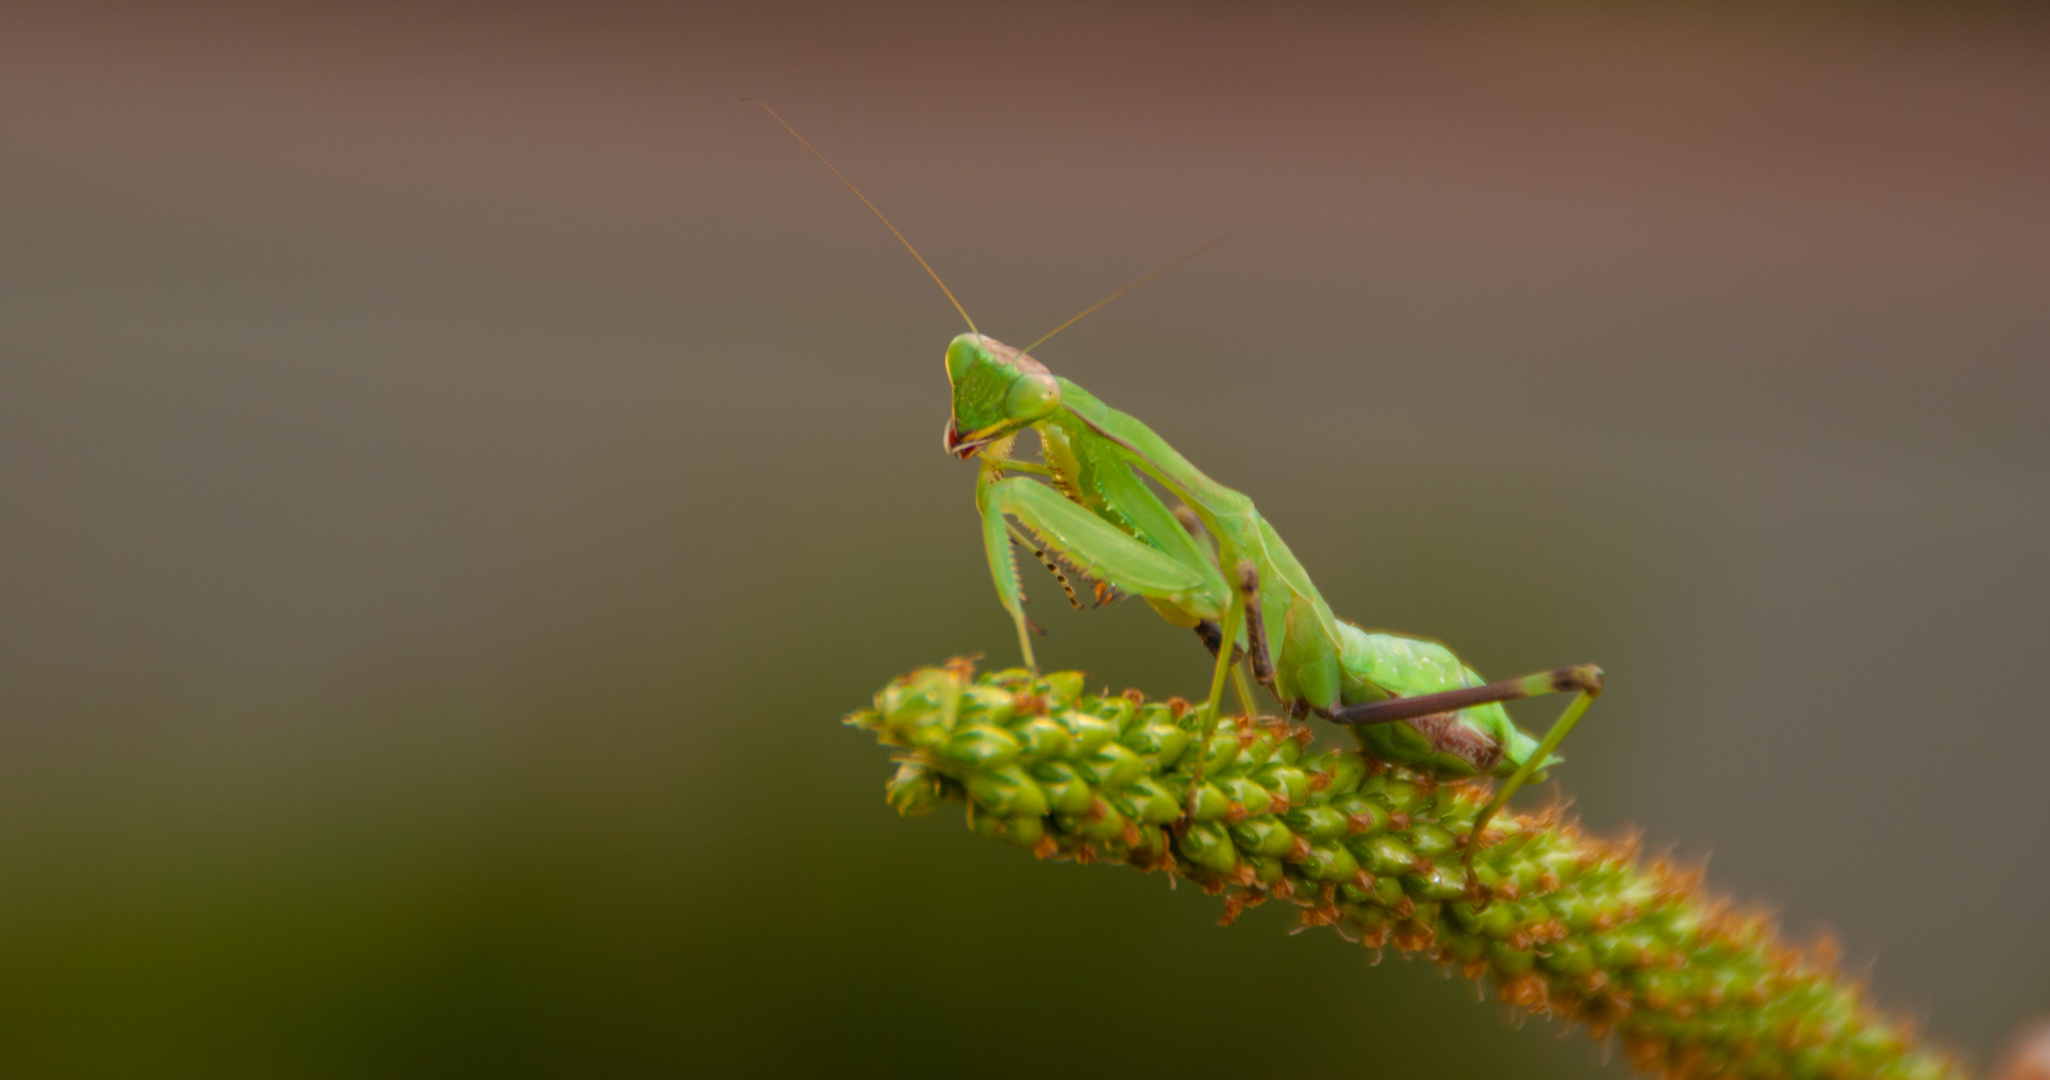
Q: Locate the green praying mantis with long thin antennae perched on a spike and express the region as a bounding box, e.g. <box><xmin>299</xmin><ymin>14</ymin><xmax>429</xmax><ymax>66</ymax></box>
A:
<box><xmin>756</xmin><ymin>102</ymin><xmax>1603</xmax><ymax>889</ymax></box>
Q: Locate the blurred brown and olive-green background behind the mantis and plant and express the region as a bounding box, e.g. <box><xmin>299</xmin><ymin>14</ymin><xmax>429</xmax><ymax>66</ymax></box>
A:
<box><xmin>0</xmin><ymin>4</ymin><xmax>2050</xmax><ymax>1078</ymax></box>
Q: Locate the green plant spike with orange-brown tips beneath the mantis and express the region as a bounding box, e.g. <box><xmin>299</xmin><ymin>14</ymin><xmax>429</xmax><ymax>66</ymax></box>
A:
<box><xmin>847</xmin><ymin>660</ymin><xmax>1964</xmax><ymax>1080</ymax></box>
